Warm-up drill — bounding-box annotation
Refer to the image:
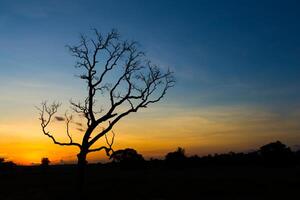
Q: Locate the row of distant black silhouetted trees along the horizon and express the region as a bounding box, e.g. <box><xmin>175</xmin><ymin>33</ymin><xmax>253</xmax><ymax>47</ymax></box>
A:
<box><xmin>0</xmin><ymin>141</ymin><xmax>300</xmax><ymax>169</ymax></box>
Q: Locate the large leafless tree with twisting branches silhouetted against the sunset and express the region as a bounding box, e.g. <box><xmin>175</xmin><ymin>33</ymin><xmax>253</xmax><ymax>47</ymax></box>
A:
<box><xmin>38</xmin><ymin>29</ymin><xmax>174</xmax><ymax>181</ymax></box>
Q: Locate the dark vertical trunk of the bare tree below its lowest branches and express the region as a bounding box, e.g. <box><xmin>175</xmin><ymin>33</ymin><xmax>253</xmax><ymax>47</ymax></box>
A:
<box><xmin>77</xmin><ymin>150</ymin><xmax>87</xmax><ymax>199</ymax></box>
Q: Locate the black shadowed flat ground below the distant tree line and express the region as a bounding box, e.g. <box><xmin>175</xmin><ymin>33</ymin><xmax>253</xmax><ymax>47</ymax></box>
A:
<box><xmin>0</xmin><ymin>165</ymin><xmax>300</xmax><ymax>200</ymax></box>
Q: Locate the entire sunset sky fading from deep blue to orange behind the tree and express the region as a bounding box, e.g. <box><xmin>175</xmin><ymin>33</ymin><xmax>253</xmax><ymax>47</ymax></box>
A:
<box><xmin>0</xmin><ymin>0</ymin><xmax>300</xmax><ymax>164</ymax></box>
